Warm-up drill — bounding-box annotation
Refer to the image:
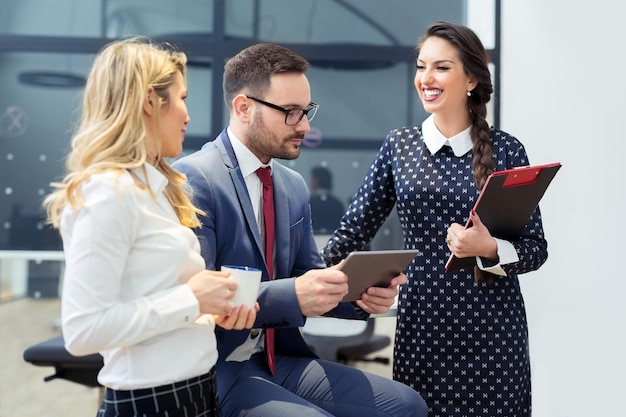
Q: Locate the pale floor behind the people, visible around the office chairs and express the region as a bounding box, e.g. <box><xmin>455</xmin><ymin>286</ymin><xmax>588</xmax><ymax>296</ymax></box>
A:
<box><xmin>0</xmin><ymin>298</ymin><xmax>394</xmax><ymax>417</ymax></box>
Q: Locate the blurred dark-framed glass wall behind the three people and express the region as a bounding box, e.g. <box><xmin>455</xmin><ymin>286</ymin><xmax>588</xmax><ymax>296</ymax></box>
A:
<box><xmin>0</xmin><ymin>0</ymin><xmax>499</xmax><ymax>251</ymax></box>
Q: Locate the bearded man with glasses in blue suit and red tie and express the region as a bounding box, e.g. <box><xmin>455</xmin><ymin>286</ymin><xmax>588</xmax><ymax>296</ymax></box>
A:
<box><xmin>174</xmin><ymin>44</ymin><xmax>426</xmax><ymax>417</ymax></box>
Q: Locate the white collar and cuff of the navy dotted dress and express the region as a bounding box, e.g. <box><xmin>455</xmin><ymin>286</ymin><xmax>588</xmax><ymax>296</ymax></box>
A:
<box><xmin>422</xmin><ymin>114</ymin><xmax>519</xmax><ymax>276</ymax></box>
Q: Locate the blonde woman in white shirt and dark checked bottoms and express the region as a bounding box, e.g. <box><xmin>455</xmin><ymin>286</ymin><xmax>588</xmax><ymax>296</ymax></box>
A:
<box><xmin>44</xmin><ymin>38</ymin><xmax>256</xmax><ymax>416</ymax></box>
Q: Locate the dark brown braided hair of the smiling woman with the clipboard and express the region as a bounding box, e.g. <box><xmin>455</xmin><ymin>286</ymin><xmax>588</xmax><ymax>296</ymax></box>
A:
<box><xmin>418</xmin><ymin>21</ymin><xmax>496</xmax><ymax>284</ymax></box>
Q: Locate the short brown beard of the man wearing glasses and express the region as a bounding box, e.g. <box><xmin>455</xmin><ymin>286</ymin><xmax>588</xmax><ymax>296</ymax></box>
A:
<box><xmin>247</xmin><ymin>113</ymin><xmax>304</xmax><ymax>161</ymax></box>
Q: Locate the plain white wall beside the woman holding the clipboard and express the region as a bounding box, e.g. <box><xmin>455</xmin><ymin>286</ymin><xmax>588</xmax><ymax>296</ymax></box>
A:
<box><xmin>500</xmin><ymin>0</ymin><xmax>626</xmax><ymax>417</ymax></box>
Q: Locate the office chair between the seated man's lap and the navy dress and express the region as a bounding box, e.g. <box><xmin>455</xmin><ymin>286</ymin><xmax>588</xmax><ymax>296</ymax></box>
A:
<box><xmin>302</xmin><ymin>317</ymin><xmax>391</xmax><ymax>364</ymax></box>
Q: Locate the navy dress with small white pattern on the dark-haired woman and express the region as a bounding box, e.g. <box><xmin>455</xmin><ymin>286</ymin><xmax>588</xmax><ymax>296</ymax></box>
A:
<box><xmin>323</xmin><ymin>126</ymin><xmax>547</xmax><ymax>417</ymax></box>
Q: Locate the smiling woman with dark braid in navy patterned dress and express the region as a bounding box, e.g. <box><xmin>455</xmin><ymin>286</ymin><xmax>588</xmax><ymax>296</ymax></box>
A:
<box><xmin>323</xmin><ymin>22</ymin><xmax>547</xmax><ymax>417</ymax></box>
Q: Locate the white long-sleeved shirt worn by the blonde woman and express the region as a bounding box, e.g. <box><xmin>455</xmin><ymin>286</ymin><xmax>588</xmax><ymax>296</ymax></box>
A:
<box><xmin>61</xmin><ymin>164</ymin><xmax>217</xmax><ymax>389</ymax></box>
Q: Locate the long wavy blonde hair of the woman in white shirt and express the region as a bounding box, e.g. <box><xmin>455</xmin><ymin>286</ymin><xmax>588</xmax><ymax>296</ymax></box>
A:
<box><xmin>43</xmin><ymin>37</ymin><xmax>204</xmax><ymax>228</ymax></box>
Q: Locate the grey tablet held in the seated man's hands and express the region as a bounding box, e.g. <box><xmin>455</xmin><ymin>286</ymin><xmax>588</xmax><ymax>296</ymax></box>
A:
<box><xmin>341</xmin><ymin>250</ymin><xmax>419</xmax><ymax>301</ymax></box>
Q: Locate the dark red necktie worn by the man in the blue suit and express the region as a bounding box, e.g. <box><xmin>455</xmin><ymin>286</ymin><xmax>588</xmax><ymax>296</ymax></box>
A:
<box><xmin>256</xmin><ymin>167</ymin><xmax>275</xmax><ymax>375</ymax></box>
